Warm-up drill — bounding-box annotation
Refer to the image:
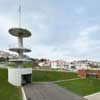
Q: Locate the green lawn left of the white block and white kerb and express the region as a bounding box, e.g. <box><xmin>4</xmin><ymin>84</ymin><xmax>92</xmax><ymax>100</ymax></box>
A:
<box><xmin>0</xmin><ymin>69</ymin><xmax>22</xmax><ymax>100</ymax></box>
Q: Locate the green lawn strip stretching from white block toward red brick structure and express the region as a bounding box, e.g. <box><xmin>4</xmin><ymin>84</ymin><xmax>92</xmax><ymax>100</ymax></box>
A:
<box><xmin>32</xmin><ymin>70</ymin><xmax>77</xmax><ymax>82</ymax></box>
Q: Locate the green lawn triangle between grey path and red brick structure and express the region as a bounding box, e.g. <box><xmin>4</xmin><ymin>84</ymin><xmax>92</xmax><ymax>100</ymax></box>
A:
<box><xmin>57</xmin><ymin>78</ymin><xmax>100</xmax><ymax>96</ymax></box>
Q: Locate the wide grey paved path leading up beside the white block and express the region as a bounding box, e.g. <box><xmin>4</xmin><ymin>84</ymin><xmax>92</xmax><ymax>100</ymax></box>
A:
<box><xmin>24</xmin><ymin>83</ymin><xmax>86</xmax><ymax>100</ymax></box>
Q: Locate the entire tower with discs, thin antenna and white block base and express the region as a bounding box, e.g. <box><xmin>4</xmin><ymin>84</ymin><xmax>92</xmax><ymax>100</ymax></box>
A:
<box><xmin>8</xmin><ymin>0</ymin><xmax>32</xmax><ymax>86</ymax></box>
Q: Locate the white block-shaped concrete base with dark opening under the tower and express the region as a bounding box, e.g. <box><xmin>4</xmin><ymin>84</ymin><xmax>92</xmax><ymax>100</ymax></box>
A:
<box><xmin>8</xmin><ymin>68</ymin><xmax>32</xmax><ymax>86</ymax></box>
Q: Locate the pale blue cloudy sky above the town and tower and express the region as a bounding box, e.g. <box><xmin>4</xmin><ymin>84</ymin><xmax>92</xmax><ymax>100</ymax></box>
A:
<box><xmin>0</xmin><ymin>0</ymin><xmax>100</xmax><ymax>61</ymax></box>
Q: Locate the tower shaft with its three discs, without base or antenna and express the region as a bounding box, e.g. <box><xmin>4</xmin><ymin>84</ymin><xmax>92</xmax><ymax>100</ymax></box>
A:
<box><xmin>9</xmin><ymin>28</ymin><xmax>31</xmax><ymax>68</ymax></box>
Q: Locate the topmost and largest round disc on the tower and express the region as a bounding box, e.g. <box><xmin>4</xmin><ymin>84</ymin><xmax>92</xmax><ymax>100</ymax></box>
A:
<box><xmin>9</xmin><ymin>28</ymin><xmax>31</xmax><ymax>37</ymax></box>
